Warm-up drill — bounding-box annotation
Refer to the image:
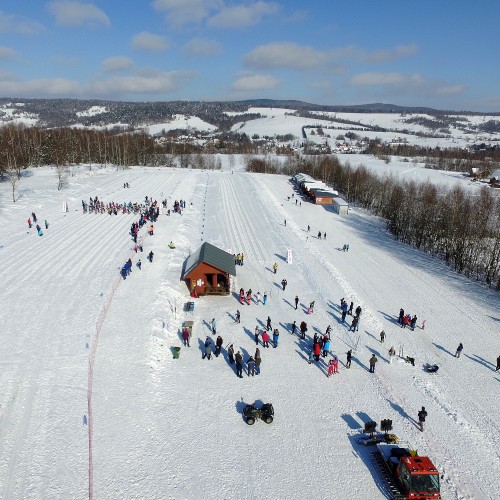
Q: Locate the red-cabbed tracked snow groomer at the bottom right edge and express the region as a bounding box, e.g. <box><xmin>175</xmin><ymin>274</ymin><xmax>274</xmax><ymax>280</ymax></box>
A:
<box><xmin>372</xmin><ymin>442</ymin><xmax>441</xmax><ymax>500</ymax></box>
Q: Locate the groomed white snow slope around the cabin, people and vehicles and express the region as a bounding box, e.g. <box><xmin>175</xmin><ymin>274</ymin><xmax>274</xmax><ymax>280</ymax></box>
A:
<box><xmin>0</xmin><ymin>164</ymin><xmax>500</xmax><ymax>500</ymax></box>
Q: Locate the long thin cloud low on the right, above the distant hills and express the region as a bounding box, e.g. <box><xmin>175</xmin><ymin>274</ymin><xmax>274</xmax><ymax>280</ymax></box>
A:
<box><xmin>350</xmin><ymin>72</ymin><xmax>465</xmax><ymax>97</ymax></box>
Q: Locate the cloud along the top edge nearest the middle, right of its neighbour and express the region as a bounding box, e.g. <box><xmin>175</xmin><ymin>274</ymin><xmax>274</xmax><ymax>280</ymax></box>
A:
<box><xmin>207</xmin><ymin>1</ymin><xmax>279</xmax><ymax>28</ymax></box>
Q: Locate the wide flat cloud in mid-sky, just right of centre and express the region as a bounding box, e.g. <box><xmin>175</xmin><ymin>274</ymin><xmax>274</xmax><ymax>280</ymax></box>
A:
<box><xmin>243</xmin><ymin>42</ymin><xmax>335</xmax><ymax>70</ymax></box>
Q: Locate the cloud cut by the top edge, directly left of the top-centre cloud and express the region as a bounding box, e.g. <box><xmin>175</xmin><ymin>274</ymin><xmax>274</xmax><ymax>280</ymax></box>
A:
<box><xmin>153</xmin><ymin>0</ymin><xmax>224</xmax><ymax>27</ymax></box>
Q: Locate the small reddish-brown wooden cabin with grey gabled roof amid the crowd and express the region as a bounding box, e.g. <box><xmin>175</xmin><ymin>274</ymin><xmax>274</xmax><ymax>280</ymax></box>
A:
<box><xmin>183</xmin><ymin>242</ymin><xmax>236</xmax><ymax>295</ymax></box>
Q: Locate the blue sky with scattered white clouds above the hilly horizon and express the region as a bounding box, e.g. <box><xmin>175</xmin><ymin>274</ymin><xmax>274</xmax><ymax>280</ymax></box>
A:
<box><xmin>0</xmin><ymin>0</ymin><xmax>500</xmax><ymax>112</ymax></box>
